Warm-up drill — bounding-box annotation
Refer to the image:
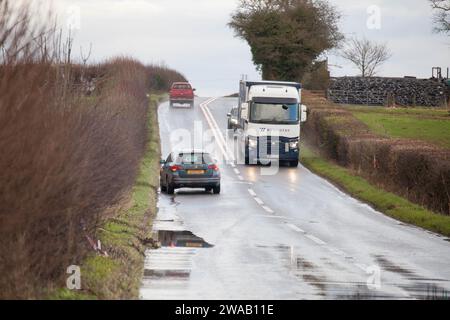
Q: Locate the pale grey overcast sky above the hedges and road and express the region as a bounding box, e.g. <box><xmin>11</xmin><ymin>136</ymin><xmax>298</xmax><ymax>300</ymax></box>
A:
<box><xmin>54</xmin><ymin>0</ymin><xmax>450</xmax><ymax>96</ymax></box>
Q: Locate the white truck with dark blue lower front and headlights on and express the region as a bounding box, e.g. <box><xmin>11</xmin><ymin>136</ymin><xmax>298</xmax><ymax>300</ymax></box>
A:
<box><xmin>236</xmin><ymin>80</ymin><xmax>306</xmax><ymax>167</ymax></box>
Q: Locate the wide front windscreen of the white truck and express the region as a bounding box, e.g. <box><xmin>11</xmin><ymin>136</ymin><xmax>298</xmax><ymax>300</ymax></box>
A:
<box><xmin>250</xmin><ymin>102</ymin><xmax>299</xmax><ymax>124</ymax></box>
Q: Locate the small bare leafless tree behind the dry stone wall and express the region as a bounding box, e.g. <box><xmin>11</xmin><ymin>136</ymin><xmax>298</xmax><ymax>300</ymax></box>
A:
<box><xmin>340</xmin><ymin>38</ymin><xmax>391</xmax><ymax>77</ymax></box>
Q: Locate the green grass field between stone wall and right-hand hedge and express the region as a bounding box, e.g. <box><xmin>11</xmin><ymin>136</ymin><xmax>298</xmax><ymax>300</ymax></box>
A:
<box><xmin>349</xmin><ymin>106</ymin><xmax>450</xmax><ymax>148</ymax></box>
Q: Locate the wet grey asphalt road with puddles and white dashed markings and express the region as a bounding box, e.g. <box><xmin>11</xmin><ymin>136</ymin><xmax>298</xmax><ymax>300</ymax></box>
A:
<box><xmin>140</xmin><ymin>98</ymin><xmax>450</xmax><ymax>299</ymax></box>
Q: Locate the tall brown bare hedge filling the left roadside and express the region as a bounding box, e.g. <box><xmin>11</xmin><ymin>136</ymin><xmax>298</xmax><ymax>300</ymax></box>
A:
<box><xmin>0</xmin><ymin>0</ymin><xmax>150</xmax><ymax>298</ymax></box>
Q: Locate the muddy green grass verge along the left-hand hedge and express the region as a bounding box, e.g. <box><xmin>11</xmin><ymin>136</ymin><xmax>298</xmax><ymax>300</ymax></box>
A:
<box><xmin>49</xmin><ymin>94</ymin><xmax>164</xmax><ymax>300</ymax></box>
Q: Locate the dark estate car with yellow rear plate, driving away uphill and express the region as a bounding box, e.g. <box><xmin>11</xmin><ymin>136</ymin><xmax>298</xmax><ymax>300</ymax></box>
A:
<box><xmin>160</xmin><ymin>150</ymin><xmax>220</xmax><ymax>194</ymax></box>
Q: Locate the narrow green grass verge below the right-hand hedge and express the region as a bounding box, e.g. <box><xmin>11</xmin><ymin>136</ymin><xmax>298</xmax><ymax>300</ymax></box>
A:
<box><xmin>300</xmin><ymin>146</ymin><xmax>450</xmax><ymax>237</ymax></box>
